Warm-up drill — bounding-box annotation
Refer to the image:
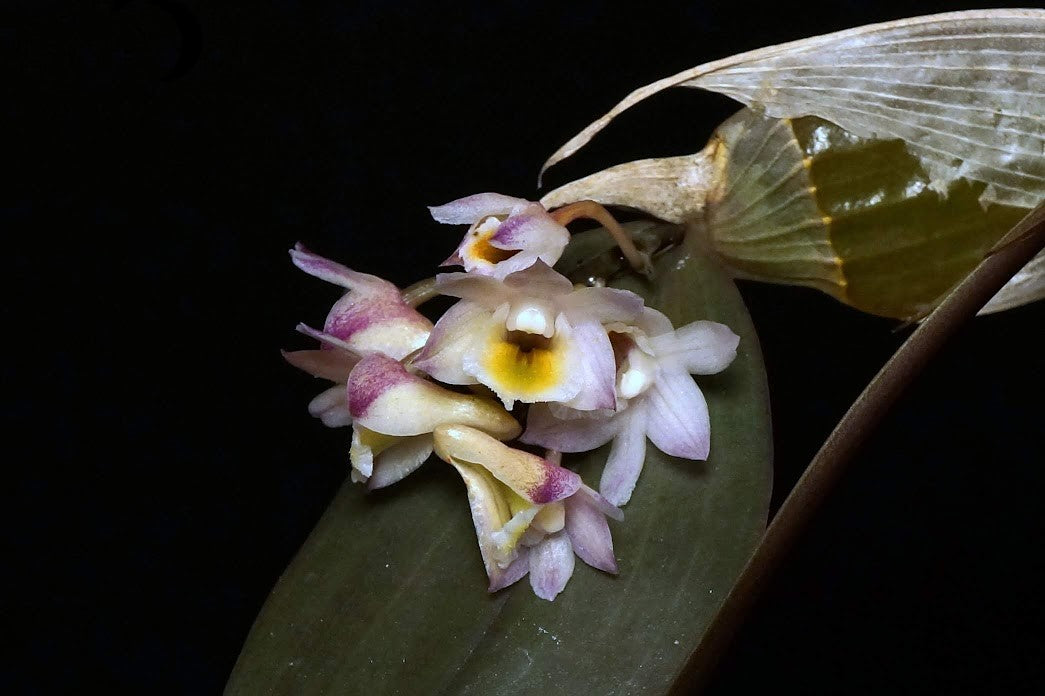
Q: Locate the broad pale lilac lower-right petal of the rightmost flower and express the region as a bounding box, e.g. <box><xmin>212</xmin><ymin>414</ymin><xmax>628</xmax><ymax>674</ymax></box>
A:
<box><xmin>643</xmin><ymin>368</ymin><xmax>711</xmax><ymax>457</ymax></box>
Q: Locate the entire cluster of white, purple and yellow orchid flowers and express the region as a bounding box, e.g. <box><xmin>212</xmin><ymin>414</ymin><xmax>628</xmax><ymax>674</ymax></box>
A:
<box><xmin>284</xmin><ymin>193</ymin><xmax>739</xmax><ymax>600</ymax></box>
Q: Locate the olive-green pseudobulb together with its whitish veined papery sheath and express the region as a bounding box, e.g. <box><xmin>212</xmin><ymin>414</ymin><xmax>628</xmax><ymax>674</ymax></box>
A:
<box><xmin>541</xmin><ymin>9</ymin><xmax>1045</xmax><ymax>320</ymax></box>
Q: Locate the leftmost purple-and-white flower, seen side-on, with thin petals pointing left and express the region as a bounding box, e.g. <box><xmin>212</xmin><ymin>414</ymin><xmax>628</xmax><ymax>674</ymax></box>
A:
<box><xmin>283</xmin><ymin>243</ymin><xmax>432</xmax><ymax>427</ymax></box>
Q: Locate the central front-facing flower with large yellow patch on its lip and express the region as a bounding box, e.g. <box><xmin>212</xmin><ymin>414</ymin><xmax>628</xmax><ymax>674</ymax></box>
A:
<box><xmin>414</xmin><ymin>260</ymin><xmax>643</xmax><ymax>411</ymax></box>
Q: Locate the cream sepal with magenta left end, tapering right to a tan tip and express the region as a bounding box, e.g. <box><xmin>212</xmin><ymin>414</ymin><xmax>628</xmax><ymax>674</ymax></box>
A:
<box><xmin>348</xmin><ymin>353</ymin><xmax>521</xmax><ymax>440</ymax></box>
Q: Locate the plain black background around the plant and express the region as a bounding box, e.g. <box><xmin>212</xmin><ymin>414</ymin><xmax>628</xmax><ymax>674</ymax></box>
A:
<box><xmin>10</xmin><ymin>0</ymin><xmax>1045</xmax><ymax>694</ymax></box>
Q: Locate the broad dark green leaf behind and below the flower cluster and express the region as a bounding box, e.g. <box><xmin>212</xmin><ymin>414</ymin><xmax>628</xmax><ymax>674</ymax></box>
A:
<box><xmin>226</xmin><ymin>224</ymin><xmax>771</xmax><ymax>696</ymax></box>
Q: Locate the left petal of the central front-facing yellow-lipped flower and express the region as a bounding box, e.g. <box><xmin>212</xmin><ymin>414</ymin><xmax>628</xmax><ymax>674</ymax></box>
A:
<box><xmin>414</xmin><ymin>300</ymin><xmax>491</xmax><ymax>385</ymax></box>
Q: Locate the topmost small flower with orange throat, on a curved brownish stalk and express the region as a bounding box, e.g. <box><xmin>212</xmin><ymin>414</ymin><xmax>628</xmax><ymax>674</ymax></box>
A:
<box><xmin>428</xmin><ymin>193</ymin><xmax>570</xmax><ymax>278</ymax></box>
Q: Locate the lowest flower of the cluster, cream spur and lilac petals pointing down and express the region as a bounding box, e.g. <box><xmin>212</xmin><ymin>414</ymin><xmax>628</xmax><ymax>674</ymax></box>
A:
<box><xmin>435</xmin><ymin>425</ymin><xmax>623</xmax><ymax>601</ymax></box>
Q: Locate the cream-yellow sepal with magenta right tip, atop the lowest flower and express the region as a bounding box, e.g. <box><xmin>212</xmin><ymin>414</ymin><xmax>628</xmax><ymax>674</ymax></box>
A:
<box><xmin>434</xmin><ymin>425</ymin><xmax>581</xmax><ymax>505</ymax></box>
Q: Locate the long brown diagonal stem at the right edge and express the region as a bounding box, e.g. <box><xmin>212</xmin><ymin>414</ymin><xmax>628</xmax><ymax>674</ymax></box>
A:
<box><xmin>673</xmin><ymin>203</ymin><xmax>1045</xmax><ymax>693</ymax></box>
